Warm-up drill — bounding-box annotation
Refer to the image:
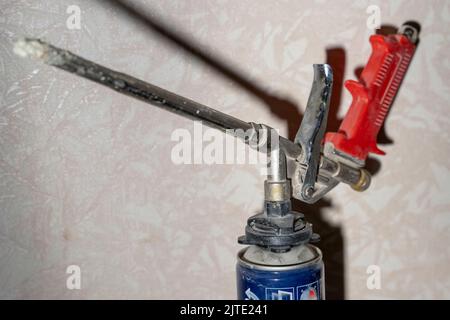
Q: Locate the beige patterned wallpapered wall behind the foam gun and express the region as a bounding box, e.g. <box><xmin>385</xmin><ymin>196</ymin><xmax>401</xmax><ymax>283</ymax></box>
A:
<box><xmin>0</xmin><ymin>0</ymin><xmax>450</xmax><ymax>299</ymax></box>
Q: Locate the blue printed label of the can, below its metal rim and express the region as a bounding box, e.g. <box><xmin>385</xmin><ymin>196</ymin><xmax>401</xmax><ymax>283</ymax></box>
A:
<box><xmin>236</xmin><ymin>250</ymin><xmax>325</xmax><ymax>300</ymax></box>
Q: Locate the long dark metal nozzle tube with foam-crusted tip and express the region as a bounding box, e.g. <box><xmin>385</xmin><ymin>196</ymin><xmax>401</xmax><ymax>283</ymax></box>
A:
<box><xmin>14</xmin><ymin>39</ymin><xmax>301</xmax><ymax>158</ymax></box>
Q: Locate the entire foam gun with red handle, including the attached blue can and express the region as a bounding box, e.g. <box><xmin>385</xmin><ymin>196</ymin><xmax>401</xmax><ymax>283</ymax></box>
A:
<box><xmin>14</xmin><ymin>23</ymin><xmax>419</xmax><ymax>300</ymax></box>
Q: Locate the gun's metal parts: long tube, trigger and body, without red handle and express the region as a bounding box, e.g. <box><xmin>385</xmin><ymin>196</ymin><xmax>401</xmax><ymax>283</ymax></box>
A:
<box><xmin>15</xmin><ymin>39</ymin><xmax>370</xmax><ymax>203</ymax></box>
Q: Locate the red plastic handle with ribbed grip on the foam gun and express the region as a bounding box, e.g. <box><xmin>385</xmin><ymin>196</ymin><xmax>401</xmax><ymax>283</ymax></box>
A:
<box><xmin>324</xmin><ymin>34</ymin><xmax>415</xmax><ymax>162</ymax></box>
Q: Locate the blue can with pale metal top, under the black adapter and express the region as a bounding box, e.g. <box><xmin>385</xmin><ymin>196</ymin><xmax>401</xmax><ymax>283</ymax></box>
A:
<box><xmin>236</xmin><ymin>244</ymin><xmax>325</xmax><ymax>300</ymax></box>
